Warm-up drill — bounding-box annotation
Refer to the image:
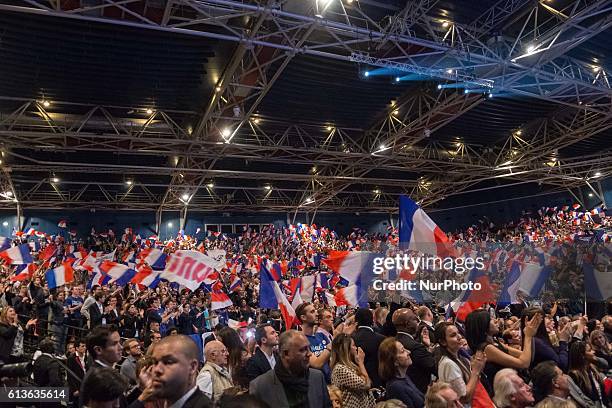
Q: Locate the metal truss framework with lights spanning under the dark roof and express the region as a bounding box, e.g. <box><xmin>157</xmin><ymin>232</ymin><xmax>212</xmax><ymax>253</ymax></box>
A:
<box><xmin>0</xmin><ymin>0</ymin><xmax>612</xmax><ymax>220</ymax></box>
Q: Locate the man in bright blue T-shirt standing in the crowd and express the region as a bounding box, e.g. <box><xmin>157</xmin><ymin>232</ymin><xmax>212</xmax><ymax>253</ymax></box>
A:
<box><xmin>295</xmin><ymin>302</ymin><xmax>331</xmax><ymax>383</ymax></box>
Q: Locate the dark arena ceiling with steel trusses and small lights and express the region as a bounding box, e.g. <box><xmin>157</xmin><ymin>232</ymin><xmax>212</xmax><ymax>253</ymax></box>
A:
<box><xmin>0</xmin><ymin>0</ymin><xmax>612</xmax><ymax>230</ymax></box>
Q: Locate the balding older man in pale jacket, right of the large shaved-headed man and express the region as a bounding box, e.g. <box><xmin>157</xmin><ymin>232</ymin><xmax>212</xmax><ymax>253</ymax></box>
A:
<box><xmin>196</xmin><ymin>340</ymin><xmax>234</xmax><ymax>401</ymax></box>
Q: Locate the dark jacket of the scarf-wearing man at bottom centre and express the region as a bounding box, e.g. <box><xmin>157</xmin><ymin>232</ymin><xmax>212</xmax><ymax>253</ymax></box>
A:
<box><xmin>249</xmin><ymin>361</ymin><xmax>332</xmax><ymax>408</ymax></box>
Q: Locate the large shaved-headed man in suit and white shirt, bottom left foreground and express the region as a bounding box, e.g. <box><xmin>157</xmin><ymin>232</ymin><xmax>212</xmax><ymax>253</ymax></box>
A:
<box><xmin>130</xmin><ymin>335</ymin><xmax>213</xmax><ymax>408</ymax></box>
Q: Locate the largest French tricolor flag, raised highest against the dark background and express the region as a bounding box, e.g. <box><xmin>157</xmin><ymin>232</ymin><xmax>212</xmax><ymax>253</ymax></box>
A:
<box><xmin>399</xmin><ymin>195</ymin><xmax>452</xmax><ymax>258</ymax></box>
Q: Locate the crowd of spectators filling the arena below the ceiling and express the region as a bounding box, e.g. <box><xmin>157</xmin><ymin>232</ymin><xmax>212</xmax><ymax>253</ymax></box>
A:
<box><xmin>0</xmin><ymin>202</ymin><xmax>612</xmax><ymax>408</ymax></box>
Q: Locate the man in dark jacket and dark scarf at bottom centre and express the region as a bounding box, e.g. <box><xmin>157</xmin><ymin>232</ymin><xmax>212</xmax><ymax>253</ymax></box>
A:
<box><xmin>249</xmin><ymin>330</ymin><xmax>332</xmax><ymax>408</ymax></box>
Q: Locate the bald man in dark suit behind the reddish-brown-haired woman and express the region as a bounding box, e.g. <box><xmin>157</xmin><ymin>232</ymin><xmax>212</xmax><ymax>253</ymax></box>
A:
<box><xmin>392</xmin><ymin>308</ymin><xmax>437</xmax><ymax>394</ymax></box>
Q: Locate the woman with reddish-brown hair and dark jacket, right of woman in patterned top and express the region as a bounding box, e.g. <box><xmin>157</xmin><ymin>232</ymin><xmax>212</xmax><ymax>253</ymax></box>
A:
<box><xmin>378</xmin><ymin>337</ymin><xmax>424</xmax><ymax>408</ymax></box>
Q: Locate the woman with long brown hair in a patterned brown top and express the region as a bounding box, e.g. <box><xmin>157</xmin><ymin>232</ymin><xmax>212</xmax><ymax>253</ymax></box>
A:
<box><xmin>330</xmin><ymin>333</ymin><xmax>376</xmax><ymax>408</ymax></box>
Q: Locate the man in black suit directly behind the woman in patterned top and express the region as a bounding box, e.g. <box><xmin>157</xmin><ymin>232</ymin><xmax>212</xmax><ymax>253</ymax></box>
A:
<box><xmin>353</xmin><ymin>308</ymin><xmax>385</xmax><ymax>387</ymax></box>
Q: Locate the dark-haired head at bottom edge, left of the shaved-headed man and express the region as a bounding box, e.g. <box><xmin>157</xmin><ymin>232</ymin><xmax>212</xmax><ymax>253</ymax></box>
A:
<box><xmin>80</xmin><ymin>367</ymin><xmax>128</xmax><ymax>408</ymax></box>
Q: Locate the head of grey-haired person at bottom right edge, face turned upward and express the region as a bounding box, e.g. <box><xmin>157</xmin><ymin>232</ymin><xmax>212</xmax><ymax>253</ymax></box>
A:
<box><xmin>493</xmin><ymin>368</ymin><xmax>534</xmax><ymax>408</ymax></box>
